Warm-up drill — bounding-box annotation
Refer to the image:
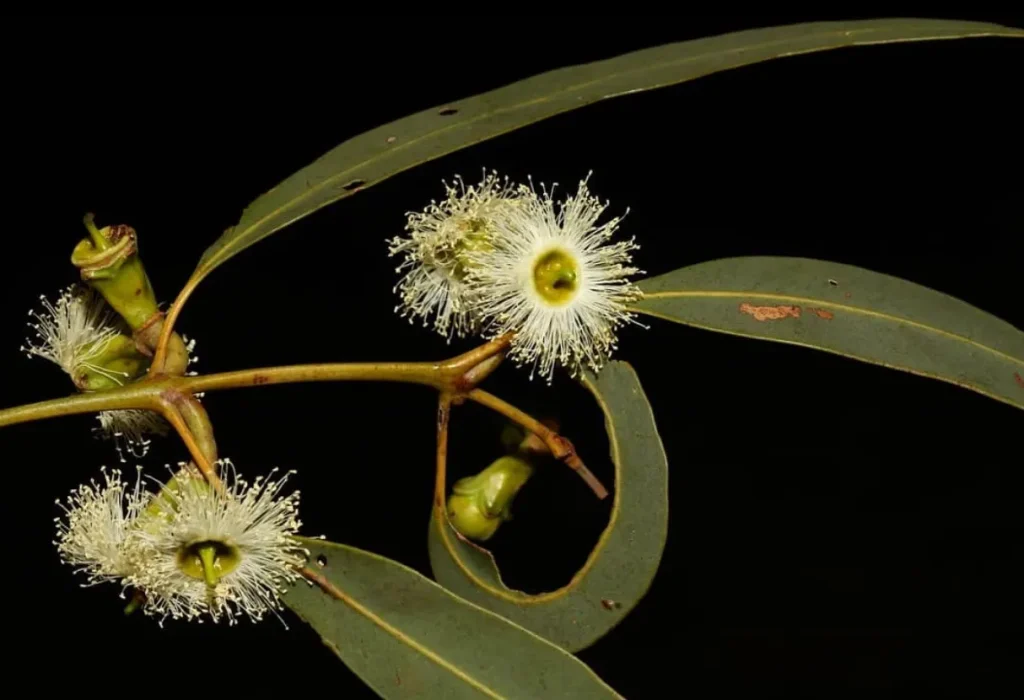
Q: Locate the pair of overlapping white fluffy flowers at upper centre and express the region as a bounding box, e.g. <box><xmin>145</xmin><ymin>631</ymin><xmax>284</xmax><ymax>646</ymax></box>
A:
<box><xmin>388</xmin><ymin>173</ymin><xmax>641</xmax><ymax>383</ymax></box>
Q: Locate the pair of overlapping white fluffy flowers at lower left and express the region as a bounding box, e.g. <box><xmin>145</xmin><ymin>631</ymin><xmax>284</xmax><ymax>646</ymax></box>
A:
<box><xmin>54</xmin><ymin>460</ymin><xmax>308</xmax><ymax>624</ymax></box>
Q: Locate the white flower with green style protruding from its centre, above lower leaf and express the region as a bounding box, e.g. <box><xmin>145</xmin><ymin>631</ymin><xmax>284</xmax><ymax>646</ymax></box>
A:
<box><xmin>130</xmin><ymin>460</ymin><xmax>308</xmax><ymax>623</ymax></box>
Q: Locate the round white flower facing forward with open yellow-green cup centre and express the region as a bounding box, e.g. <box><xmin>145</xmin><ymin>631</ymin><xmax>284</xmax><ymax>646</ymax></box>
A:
<box><xmin>466</xmin><ymin>175</ymin><xmax>641</xmax><ymax>383</ymax></box>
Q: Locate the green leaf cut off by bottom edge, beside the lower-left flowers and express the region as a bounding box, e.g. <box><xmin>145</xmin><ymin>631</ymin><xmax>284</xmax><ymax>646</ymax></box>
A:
<box><xmin>284</xmin><ymin>539</ymin><xmax>621</xmax><ymax>700</ymax></box>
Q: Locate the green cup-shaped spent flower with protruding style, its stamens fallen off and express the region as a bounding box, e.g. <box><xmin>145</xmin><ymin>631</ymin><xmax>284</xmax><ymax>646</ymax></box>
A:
<box><xmin>71</xmin><ymin>214</ymin><xmax>158</xmax><ymax>331</ymax></box>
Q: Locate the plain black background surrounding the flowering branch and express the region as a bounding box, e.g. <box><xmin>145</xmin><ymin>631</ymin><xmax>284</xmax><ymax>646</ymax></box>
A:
<box><xmin>0</xmin><ymin>10</ymin><xmax>1024</xmax><ymax>698</ymax></box>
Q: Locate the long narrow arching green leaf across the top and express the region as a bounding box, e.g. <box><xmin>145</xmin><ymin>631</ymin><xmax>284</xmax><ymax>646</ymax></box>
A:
<box><xmin>193</xmin><ymin>19</ymin><xmax>1024</xmax><ymax>283</ymax></box>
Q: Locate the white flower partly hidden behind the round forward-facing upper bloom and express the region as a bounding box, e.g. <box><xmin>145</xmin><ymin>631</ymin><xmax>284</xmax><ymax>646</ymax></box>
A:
<box><xmin>388</xmin><ymin>173</ymin><xmax>515</xmax><ymax>342</ymax></box>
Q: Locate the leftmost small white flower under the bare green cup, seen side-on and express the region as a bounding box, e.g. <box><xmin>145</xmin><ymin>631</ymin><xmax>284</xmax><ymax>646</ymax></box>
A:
<box><xmin>20</xmin><ymin>286</ymin><xmax>124</xmax><ymax>384</ymax></box>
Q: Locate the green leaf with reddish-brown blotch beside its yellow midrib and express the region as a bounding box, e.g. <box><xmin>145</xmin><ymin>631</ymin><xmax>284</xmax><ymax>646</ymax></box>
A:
<box><xmin>635</xmin><ymin>257</ymin><xmax>1024</xmax><ymax>408</ymax></box>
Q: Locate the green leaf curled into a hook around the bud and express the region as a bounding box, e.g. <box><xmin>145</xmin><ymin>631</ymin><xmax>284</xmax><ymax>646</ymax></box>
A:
<box><xmin>429</xmin><ymin>361</ymin><xmax>669</xmax><ymax>651</ymax></box>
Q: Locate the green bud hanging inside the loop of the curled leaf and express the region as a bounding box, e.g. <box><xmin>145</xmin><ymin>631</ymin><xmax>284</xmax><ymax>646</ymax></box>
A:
<box><xmin>447</xmin><ymin>455</ymin><xmax>534</xmax><ymax>541</ymax></box>
